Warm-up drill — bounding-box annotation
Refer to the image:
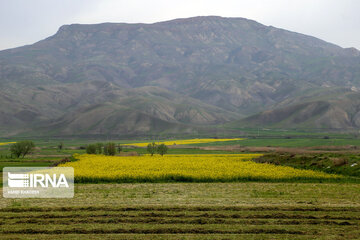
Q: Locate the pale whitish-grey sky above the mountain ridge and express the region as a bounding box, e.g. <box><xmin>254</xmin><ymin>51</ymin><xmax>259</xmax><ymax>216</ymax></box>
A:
<box><xmin>0</xmin><ymin>0</ymin><xmax>360</xmax><ymax>50</ymax></box>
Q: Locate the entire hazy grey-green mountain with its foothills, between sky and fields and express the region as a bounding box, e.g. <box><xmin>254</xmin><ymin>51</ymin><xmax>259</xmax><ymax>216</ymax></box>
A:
<box><xmin>0</xmin><ymin>16</ymin><xmax>360</xmax><ymax>135</ymax></box>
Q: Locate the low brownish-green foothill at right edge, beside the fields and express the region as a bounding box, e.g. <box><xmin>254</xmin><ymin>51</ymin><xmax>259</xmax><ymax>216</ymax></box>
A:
<box><xmin>229</xmin><ymin>92</ymin><xmax>360</xmax><ymax>130</ymax></box>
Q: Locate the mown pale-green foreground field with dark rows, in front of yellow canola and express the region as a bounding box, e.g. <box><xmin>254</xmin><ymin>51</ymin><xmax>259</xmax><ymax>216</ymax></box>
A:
<box><xmin>0</xmin><ymin>183</ymin><xmax>360</xmax><ymax>239</ymax></box>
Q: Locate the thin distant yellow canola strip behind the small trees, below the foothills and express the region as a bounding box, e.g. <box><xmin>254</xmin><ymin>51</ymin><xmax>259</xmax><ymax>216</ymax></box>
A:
<box><xmin>123</xmin><ymin>138</ymin><xmax>244</xmax><ymax>147</ymax></box>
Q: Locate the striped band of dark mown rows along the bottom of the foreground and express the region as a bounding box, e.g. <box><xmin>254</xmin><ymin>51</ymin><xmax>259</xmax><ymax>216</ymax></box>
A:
<box><xmin>0</xmin><ymin>206</ymin><xmax>360</xmax><ymax>239</ymax></box>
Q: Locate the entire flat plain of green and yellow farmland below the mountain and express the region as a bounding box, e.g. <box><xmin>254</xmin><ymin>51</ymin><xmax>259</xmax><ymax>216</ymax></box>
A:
<box><xmin>0</xmin><ymin>139</ymin><xmax>360</xmax><ymax>239</ymax></box>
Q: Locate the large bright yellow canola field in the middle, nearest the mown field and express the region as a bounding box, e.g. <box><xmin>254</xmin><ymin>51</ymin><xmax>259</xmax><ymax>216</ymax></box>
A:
<box><xmin>60</xmin><ymin>154</ymin><xmax>339</xmax><ymax>182</ymax></box>
